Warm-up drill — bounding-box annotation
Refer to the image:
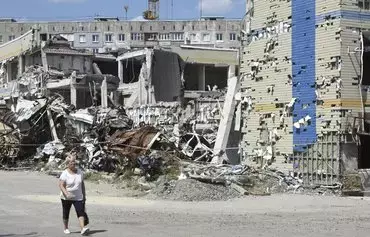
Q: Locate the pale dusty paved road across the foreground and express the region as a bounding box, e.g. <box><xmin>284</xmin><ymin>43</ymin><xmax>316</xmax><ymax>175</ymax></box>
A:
<box><xmin>0</xmin><ymin>172</ymin><xmax>370</xmax><ymax>237</ymax></box>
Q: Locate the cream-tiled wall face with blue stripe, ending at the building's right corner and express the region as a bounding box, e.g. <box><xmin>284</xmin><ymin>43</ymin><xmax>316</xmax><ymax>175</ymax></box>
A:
<box><xmin>241</xmin><ymin>0</ymin><xmax>345</xmax><ymax>182</ymax></box>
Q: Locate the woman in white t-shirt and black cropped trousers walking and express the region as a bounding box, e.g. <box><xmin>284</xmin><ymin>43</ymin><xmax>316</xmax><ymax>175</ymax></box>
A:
<box><xmin>59</xmin><ymin>155</ymin><xmax>89</xmax><ymax>235</ymax></box>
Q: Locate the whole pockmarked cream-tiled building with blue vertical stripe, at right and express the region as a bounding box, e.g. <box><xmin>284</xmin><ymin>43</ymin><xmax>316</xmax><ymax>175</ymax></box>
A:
<box><xmin>240</xmin><ymin>0</ymin><xmax>370</xmax><ymax>187</ymax></box>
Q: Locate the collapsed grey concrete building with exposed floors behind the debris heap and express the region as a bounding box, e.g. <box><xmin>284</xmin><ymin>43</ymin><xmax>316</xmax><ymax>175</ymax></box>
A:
<box><xmin>0</xmin><ymin>11</ymin><xmax>239</xmax><ymax>168</ymax></box>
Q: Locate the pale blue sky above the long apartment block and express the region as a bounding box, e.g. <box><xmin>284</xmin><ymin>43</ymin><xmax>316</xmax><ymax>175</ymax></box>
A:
<box><xmin>0</xmin><ymin>0</ymin><xmax>246</xmax><ymax>20</ymax></box>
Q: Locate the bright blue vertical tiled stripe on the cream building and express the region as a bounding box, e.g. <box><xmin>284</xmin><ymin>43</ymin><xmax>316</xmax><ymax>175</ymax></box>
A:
<box><xmin>292</xmin><ymin>0</ymin><xmax>317</xmax><ymax>151</ymax></box>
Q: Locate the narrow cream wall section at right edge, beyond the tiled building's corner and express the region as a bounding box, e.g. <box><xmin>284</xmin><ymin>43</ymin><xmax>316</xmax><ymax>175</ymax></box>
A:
<box><xmin>339</xmin><ymin>0</ymin><xmax>370</xmax><ymax>168</ymax></box>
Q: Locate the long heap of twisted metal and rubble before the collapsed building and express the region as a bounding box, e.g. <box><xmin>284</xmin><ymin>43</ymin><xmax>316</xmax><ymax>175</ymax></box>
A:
<box><xmin>0</xmin><ymin>85</ymin><xmax>308</xmax><ymax>201</ymax></box>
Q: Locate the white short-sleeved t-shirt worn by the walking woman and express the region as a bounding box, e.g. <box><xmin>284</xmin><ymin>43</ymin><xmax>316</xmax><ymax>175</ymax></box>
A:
<box><xmin>59</xmin><ymin>169</ymin><xmax>84</xmax><ymax>201</ymax></box>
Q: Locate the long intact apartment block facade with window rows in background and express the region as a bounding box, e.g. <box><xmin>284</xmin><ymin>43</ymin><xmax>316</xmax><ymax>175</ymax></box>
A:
<box><xmin>0</xmin><ymin>17</ymin><xmax>241</xmax><ymax>53</ymax></box>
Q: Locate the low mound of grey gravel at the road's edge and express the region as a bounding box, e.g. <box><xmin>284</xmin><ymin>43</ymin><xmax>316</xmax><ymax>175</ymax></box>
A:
<box><xmin>147</xmin><ymin>179</ymin><xmax>241</xmax><ymax>202</ymax></box>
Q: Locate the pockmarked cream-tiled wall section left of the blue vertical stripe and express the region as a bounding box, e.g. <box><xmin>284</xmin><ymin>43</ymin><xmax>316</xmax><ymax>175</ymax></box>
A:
<box><xmin>241</xmin><ymin>1</ymin><xmax>293</xmax><ymax>171</ymax></box>
